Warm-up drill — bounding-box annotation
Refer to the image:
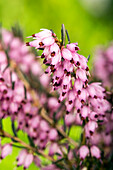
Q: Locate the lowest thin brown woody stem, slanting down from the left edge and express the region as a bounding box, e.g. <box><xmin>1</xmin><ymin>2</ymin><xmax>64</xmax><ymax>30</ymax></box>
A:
<box><xmin>0</xmin><ymin>129</ymin><xmax>55</xmax><ymax>162</ymax></box>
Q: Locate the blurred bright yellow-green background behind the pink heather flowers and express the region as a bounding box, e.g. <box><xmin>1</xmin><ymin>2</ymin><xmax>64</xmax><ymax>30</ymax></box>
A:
<box><xmin>0</xmin><ymin>0</ymin><xmax>113</xmax><ymax>170</ymax></box>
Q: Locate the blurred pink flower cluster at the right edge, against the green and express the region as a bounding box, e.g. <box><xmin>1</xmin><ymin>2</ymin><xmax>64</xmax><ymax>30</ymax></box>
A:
<box><xmin>93</xmin><ymin>43</ymin><xmax>113</xmax><ymax>88</ymax></box>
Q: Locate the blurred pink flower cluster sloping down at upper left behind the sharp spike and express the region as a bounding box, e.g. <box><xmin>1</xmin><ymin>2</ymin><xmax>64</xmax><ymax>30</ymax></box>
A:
<box><xmin>0</xmin><ymin>29</ymin><xmax>50</xmax><ymax>86</ymax></box>
